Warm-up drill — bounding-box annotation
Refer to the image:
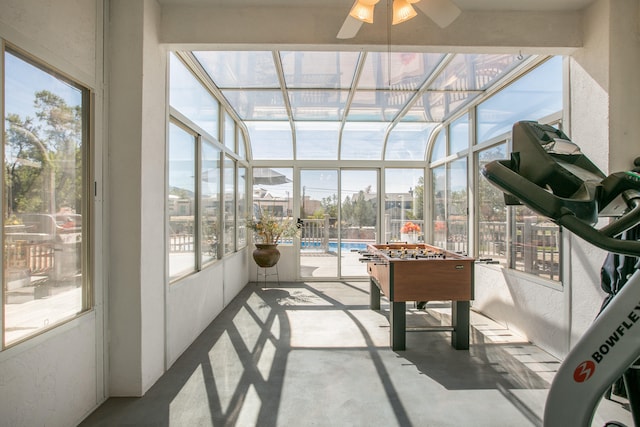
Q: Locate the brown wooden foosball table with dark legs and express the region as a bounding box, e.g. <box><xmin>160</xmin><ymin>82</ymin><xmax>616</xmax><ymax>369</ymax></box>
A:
<box><xmin>361</xmin><ymin>243</ymin><xmax>474</xmax><ymax>350</ymax></box>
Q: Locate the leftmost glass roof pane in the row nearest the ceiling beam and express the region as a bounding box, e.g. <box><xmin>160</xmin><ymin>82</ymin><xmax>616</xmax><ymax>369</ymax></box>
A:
<box><xmin>193</xmin><ymin>51</ymin><xmax>280</xmax><ymax>89</ymax></box>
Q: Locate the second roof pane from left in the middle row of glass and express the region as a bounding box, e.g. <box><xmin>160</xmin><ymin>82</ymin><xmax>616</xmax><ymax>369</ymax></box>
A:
<box><xmin>288</xmin><ymin>90</ymin><xmax>349</xmax><ymax>121</ymax></box>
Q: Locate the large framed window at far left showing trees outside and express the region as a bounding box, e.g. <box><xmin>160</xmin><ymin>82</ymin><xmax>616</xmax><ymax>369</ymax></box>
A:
<box><xmin>0</xmin><ymin>47</ymin><xmax>92</xmax><ymax>349</ymax></box>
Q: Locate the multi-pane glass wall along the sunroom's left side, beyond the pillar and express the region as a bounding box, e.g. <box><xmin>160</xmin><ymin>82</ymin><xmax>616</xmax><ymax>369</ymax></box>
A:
<box><xmin>167</xmin><ymin>53</ymin><xmax>248</xmax><ymax>282</ymax></box>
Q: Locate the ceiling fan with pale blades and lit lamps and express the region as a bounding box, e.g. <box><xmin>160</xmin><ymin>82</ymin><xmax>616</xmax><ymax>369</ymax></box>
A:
<box><xmin>337</xmin><ymin>0</ymin><xmax>460</xmax><ymax>39</ymax></box>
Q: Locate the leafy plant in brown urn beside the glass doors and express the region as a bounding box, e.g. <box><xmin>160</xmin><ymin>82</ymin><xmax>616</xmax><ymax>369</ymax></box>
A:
<box><xmin>247</xmin><ymin>211</ymin><xmax>300</xmax><ymax>268</ymax></box>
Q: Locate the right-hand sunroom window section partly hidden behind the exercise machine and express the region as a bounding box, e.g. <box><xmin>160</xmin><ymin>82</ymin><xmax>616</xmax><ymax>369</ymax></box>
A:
<box><xmin>476</xmin><ymin>57</ymin><xmax>563</xmax><ymax>280</ymax></box>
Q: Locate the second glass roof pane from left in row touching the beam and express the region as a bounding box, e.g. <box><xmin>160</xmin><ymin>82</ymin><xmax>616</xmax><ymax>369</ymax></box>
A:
<box><xmin>280</xmin><ymin>52</ymin><xmax>360</xmax><ymax>89</ymax></box>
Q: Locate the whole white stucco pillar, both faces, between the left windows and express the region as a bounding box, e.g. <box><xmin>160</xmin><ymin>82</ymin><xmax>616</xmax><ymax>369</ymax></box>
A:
<box><xmin>107</xmin><ymin>0</ymin><xmax>166</xmax><ymax>396</ymax></box>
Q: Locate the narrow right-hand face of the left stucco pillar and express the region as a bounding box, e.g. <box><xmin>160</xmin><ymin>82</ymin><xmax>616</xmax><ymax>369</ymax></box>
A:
<box><xmin>139</xmin><ymin>0</ymin><xmax>168</xmax><ymax>391</ymax></box>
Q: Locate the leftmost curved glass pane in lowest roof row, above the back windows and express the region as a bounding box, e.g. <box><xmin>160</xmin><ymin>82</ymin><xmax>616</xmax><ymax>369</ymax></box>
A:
<box><xmin>245</xmin><ymin>122</ymin><xmax>293</xmax><ymax>160</ymax></box>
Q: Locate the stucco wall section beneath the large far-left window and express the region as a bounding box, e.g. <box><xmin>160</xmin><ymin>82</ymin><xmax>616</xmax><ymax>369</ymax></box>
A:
<box><xmin>0</xmin><ymin>312</ymin><xmax>98</xmax><ymax>427</ymax></box>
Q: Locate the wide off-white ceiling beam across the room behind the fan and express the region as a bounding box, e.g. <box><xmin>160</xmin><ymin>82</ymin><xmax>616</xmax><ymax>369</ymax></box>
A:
<box><xmin>160</xmin><ymin>5</ymin><xmax>583</xmax><ymax>54</ymax></box>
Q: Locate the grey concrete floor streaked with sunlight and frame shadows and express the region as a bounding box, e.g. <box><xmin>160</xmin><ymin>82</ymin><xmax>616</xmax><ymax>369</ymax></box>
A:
<box><xmin>81</xmin><ymin>282</ymin><xmax>633</xmax><ymax>427</ymax></box>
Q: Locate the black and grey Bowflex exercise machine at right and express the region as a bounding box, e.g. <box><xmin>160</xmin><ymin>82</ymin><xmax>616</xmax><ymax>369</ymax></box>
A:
<box><xmin>482</xmin><ymin>121</ymin><xmax>640</xmax><ymax>427</ymax></box>
